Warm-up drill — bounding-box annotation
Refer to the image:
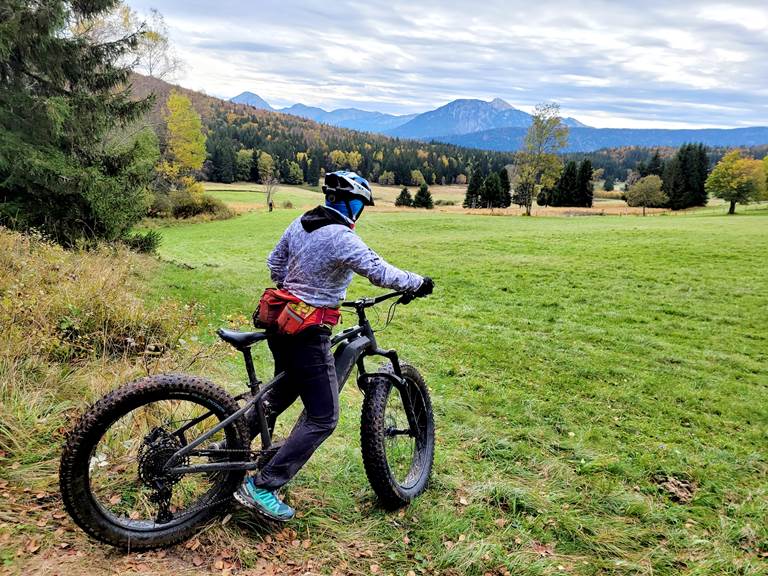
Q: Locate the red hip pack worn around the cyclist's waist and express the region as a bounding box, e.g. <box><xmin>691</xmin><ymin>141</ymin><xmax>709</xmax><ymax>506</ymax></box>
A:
<box><xmin>253</xmin><ymin>288</ymin><xmax>341</xmax><ymax>335</ymax></box>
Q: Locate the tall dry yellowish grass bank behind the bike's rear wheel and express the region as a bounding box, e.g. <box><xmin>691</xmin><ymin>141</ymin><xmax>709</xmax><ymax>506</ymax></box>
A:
<box><xmin>0</xmin><ymin>228</ymin><xmax>201</xmax><ymax>489</ymax></box>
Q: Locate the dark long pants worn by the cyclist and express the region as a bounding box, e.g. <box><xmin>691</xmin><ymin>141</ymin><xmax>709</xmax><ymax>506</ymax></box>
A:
<box><xmin>255</xmin><ymin>326</ymin><xmax>339</xmax><ymax>490</ymax></box>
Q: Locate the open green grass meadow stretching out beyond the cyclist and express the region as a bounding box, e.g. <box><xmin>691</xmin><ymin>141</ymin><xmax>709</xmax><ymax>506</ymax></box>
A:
<box><xmin>142</xmin><ymin>210</ymin><xmax>768</xmax><ymax>574</ymax></box>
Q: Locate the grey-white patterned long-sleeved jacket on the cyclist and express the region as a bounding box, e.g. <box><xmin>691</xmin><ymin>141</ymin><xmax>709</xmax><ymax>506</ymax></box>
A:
<box><xmin>267</xmin><ymin>206</ymin><xmax>423</xmax><ymax>307</ymax></box>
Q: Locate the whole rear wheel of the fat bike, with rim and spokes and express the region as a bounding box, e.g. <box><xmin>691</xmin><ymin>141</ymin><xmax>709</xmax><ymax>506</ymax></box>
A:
<box><xmin>59</xmin><ymin>374</ymin><xmax>249</xmax><ymax>550</ymax></box>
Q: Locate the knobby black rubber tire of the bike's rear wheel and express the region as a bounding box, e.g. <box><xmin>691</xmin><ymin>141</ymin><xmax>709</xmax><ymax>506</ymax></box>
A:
<box><xmin>59</xmin><ymin>374</ymin><xmax>250</xmax><ymax>550</ymax></box>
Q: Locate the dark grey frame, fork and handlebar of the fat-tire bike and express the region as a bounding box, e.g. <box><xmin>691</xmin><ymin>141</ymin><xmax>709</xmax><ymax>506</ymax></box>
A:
<box><xmin>165</xmin><ymin>292</ymin><xmax>415</xmax><ymax>475</ymax></box>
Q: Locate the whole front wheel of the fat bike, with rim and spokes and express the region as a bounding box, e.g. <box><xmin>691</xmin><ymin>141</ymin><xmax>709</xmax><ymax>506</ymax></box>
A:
<box><xmin>360</xmin><ymin>363</ymin><xmax>435</xmax><ymax>508</ymax></box>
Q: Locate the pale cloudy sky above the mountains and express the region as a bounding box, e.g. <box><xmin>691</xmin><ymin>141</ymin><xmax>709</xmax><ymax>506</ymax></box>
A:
<box><xmin>127</xmin><ymin>0</ymin><xmax>768</xmax><ymax>128</ymax></box>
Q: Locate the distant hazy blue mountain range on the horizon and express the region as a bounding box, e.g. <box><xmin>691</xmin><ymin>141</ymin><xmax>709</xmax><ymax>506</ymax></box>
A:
<box><xmin>231</xmin><ymin>92</ymin><xmax>768</xmax><ymax>152</ymax></box>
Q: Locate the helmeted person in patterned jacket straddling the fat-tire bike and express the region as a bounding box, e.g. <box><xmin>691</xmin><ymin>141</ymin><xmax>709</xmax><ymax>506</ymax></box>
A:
<box><xmin>235</xmin><ymin>171</ymin><xmax>434</xmax><ymax>521</ymax></box>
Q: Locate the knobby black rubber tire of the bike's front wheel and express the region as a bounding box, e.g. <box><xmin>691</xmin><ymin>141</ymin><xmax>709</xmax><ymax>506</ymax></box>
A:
<box><xmin>360</xmin><ymin>362</ymin><xmax>435</xmax><ymax>509</ymax></box>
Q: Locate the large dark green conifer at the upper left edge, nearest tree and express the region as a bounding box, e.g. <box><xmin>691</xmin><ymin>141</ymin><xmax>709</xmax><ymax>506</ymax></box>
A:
<box><xmin>0</xmin><ymin>0</ymin><xmax>157</xmax><ymax>244</ymax></box>
